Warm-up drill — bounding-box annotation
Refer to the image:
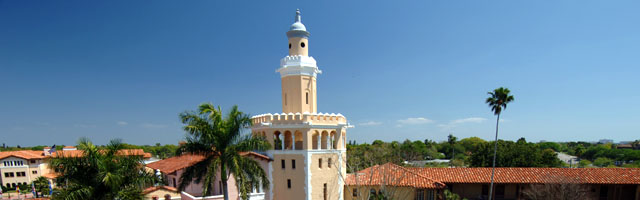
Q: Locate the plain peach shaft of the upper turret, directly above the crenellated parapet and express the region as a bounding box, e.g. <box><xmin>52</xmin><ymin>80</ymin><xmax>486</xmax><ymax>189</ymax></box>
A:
<box><xmin>282</xmin><ymin>75</ymin><xmax>317</xmax><ymax>113</ymax></box>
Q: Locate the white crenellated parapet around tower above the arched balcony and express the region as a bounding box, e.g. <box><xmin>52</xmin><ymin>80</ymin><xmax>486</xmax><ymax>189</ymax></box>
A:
<box><xmin>251</xmin><ymin>112</ymin><xmax>347</xmax><ymax>125</ymax></box>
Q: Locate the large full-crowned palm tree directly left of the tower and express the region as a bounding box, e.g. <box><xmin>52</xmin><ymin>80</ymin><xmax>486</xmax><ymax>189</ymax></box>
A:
<box><xmin>176</xmin><ymin>103</ymin><xmax>271</xmax><ymax>200</ymax></box>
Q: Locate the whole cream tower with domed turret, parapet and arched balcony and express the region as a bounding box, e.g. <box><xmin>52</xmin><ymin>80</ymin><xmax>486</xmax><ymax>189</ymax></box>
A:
<box><xmin>251</xmin><ymin>10</ymin><xmax>349</xmax><ymax>200</ymax></box>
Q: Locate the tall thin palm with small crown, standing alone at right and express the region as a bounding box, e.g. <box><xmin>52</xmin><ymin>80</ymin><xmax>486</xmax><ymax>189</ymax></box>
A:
<box><xmin>485</xmin><ymin>87</ymin><xmax>514</xmax><ymax>199</ymax></box>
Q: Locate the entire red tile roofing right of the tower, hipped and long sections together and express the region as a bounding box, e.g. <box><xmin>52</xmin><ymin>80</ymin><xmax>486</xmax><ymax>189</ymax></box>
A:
<box><xmin>346</xmin><ymin>163</ymin><xmax>640</xmax><ymax>187</ymax></box>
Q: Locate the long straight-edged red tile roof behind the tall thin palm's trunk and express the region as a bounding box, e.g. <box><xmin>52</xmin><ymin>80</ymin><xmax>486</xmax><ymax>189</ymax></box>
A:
<box><xmin>408</xmin><ymin>168</ymin><xmax>640</xmax><ymax>184</ymax></box>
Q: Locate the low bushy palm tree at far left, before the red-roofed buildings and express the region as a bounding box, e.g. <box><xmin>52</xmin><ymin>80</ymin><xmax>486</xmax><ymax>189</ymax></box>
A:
<box><xmin>49</xmin><ymin>138</ymin><xmax>157</xmax><ymax>200</ymax></box>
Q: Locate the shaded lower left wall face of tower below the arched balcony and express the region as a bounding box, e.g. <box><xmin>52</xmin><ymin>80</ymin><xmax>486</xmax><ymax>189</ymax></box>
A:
<box><xmin>271</xmin><ymin>154</ymin><xmax>306</xmax><ymax>200</ymax></box>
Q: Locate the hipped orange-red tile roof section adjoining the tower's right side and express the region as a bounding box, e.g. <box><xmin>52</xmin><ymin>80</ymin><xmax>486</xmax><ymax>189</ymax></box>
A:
<box><xmin>346</xmin><ymin>163</ymin><xmax>445</xmax><ymax>189</ymax></box>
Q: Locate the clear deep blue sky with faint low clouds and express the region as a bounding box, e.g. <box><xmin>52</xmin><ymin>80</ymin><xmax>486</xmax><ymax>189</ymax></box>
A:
<box><xmin>0</xmin><ymin>1</ymin><xmax>640</xmax><ymax>146</ymax></box>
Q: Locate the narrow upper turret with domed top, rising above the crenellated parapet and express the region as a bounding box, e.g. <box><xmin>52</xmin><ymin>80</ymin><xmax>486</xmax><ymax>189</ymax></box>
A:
<box><xmin>277</xmin><ymin>9</ymin><xmax>322</xmax><ymax>113</ymax></box>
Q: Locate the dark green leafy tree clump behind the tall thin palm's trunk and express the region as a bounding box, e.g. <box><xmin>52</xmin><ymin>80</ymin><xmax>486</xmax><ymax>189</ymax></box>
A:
<box><xmin>469</xmin><ymin>138</ymin><xmax>562</xmax><ymax>167</ymax></box>
